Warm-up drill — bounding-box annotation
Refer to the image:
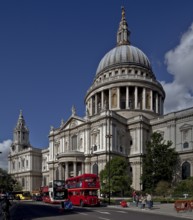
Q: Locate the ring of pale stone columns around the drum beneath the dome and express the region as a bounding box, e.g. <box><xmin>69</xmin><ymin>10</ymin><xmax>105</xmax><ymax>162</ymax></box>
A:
<box><xmin>87</xmin><ymin>86</ymin><xmax>163</xmax><ymax>116</ymax></box>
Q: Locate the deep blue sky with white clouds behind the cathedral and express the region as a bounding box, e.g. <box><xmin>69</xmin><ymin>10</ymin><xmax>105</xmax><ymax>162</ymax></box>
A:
<box><xmin>0</xmin><ymin>0</ymin><xmax>193</xmax><ymax>169</ymax></box>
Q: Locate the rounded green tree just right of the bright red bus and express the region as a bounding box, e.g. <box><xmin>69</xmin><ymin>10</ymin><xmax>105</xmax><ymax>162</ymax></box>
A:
<box><xmin>100</xmin><ymin>156</ymin><xmax>131</xmax><ymax>196</ymax></box>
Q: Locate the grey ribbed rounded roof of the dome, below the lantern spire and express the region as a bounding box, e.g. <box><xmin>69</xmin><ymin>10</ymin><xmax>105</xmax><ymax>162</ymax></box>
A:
<box><xmin>96</xmin><ymin>44</ymin><xmax>151</xmax><ymax>75</ymax></box>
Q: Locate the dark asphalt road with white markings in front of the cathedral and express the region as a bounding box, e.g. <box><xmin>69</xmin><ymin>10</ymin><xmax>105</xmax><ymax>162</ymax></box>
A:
<box><xmin>3</xmin><ymin>201</ymin><xmax>186</xmax><ymax>220</ymax></box>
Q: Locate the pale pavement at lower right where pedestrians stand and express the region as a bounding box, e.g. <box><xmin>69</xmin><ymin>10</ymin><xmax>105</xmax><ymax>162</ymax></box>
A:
<box><xmin>107</xmin><ymin>203</ymin><xmax>193</xmax><ymax>219</ymax></box>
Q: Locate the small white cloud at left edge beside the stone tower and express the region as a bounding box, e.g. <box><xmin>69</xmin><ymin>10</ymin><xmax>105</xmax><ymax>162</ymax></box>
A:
<box><xmin>0</xmin><ymin>140</ymin><xmax>12</xmax><ymax>170</ymax></box>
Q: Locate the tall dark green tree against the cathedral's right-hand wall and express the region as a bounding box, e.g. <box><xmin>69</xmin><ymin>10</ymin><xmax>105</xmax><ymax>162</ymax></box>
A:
<box><xmin>141</xmin><ymin>132</ymin><xmax>180</xmax><ymax>192</ymax></box>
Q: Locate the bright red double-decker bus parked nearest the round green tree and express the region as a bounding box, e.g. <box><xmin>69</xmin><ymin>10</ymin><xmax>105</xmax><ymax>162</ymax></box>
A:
<box><xmin>66</xmin><ymin>174</ymin><xmax>100</xmax><ymax>206</ymax></box>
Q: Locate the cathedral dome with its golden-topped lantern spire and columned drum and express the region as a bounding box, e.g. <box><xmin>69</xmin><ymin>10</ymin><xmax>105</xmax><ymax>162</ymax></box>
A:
<box><xmin>85</xmin><ymin>7</ymin><xmax>165</xmax><ymax>121</ymax></box>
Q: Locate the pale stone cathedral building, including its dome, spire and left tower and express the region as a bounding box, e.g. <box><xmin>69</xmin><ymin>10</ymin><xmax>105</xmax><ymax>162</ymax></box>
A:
<box><xmin>8</xmin><ymin>8</ymin><xmax>193</xmax><ymax>191</ymax></box>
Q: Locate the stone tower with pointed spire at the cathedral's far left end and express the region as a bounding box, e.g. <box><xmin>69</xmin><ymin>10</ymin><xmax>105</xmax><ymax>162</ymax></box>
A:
<box><xmin>8</xmin><ymin>111</ymin><xmax>42</xmax><ymax>191</ymax></box>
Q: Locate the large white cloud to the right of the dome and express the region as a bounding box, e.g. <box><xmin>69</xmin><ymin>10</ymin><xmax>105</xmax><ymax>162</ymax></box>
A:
<box><xmin>161</xmin><ymin>23</ymin><xmax>193</xmax><ymax>113</ymax></box>
